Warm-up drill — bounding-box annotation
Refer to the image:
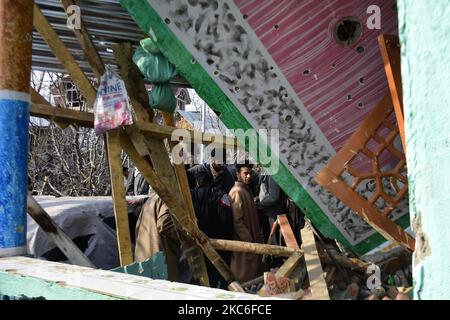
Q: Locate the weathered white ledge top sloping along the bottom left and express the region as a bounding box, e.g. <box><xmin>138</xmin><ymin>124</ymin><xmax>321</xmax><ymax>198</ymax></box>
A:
<box><xmin>0</xmin><ymin>257</ymin><xmax>276</xmax><ymax>300</ymax></box>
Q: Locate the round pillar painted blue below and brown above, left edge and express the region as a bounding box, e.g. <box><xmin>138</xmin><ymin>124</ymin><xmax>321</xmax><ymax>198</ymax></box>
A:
<box><xmin>0</xmin><ymin>0</ymin><xmax>33</xmax><ymax>257</ymax></box>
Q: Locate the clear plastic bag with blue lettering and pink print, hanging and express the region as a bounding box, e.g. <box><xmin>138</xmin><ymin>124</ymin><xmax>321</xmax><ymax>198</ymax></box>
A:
<box><xmin>94</xmin><ymin>68</ymin><xmax>133</xmax><ymax>135</ymax></box>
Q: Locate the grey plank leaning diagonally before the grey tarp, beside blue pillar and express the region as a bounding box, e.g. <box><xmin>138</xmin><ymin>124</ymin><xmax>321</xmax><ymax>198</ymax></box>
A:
<box><xmin>27</xmin><ymin>195</ymin><xmax>96</xmax><ymax>268</ymax></box>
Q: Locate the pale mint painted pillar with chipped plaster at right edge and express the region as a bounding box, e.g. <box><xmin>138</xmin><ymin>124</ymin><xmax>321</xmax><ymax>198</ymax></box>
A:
<box><xmin>398</xmin><ymin>0</ymin><xmax>450</xmax><ymax>300</ymax></box>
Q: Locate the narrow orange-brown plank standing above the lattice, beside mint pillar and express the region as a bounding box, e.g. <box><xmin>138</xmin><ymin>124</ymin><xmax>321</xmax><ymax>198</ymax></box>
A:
<box><xmin>378</xmin><ymin>34</ymin><xmax>406</xmax><ymax>150</ymax></box>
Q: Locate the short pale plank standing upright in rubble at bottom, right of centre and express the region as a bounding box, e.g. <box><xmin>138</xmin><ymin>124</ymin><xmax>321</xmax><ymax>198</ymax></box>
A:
<box><xmin>301</xmin><ymin>225</ymin><xmax>330</xmax><ymax>300</ymax></box>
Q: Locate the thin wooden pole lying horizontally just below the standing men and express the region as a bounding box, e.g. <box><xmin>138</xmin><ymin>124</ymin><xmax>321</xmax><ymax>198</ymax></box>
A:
<box><xmin>209</xmin><ymin>239</ymin><xmax>302</xmax><ymax>257</ymax></box>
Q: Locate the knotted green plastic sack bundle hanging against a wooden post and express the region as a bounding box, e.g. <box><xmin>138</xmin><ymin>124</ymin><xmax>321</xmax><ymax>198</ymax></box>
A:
<box><xmin>133</xmin><ymin>39</ymin><xmax>177</xmax><ymax>113</ymax></box>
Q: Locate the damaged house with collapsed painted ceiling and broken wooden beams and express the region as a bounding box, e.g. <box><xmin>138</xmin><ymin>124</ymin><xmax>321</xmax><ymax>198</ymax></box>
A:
<box><xmin>0</xmin><ymin>0</ymin><xmax>450</xmax><ymax>300</ymax></box>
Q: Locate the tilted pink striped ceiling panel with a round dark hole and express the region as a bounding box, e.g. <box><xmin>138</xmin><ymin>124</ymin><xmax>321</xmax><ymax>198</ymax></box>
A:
<box><xmin>234</xmin><ymin>0</ymin><xmax>398</xmax><ymax>151</ymax></box>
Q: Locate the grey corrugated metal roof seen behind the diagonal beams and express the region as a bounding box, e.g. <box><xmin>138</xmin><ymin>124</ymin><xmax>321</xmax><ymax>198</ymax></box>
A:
<box><xmin>33</xmin><ymin>0</ymin><xmax>145</xmax><ymax>76</ymax></box>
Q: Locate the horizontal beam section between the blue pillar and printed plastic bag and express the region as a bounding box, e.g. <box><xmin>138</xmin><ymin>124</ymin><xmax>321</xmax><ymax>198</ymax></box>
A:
<box><xmin>30</xmin><ymin>103</ymin><xmax>94</xmax><ymax>128</ymax></box>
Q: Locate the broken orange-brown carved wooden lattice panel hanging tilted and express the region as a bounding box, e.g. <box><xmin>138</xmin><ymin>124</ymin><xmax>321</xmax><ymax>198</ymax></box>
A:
<box><xmin>316</xmin><ymin>92</ymin><xmax>415</xmax><ymax>250</ymax></box>
